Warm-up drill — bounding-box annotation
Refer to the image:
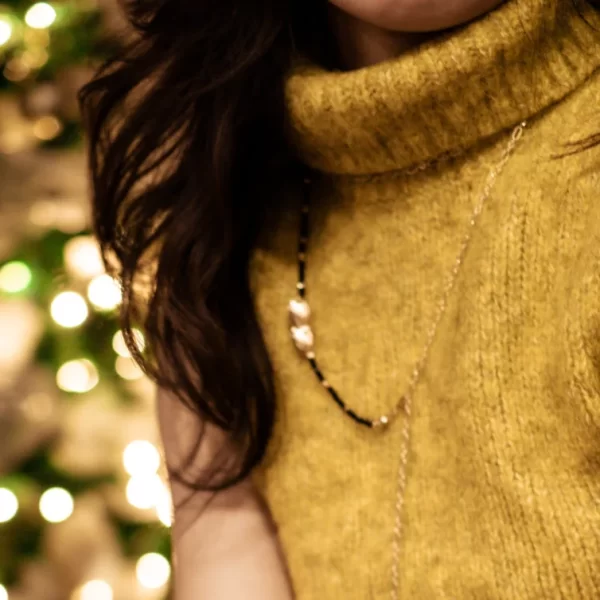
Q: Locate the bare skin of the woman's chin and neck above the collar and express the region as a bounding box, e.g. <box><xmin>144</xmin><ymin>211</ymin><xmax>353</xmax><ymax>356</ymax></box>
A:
<box><xmin>330</xmin><ymin>0</ymin><xmax>504</xmax><ymax>69</ymax></box>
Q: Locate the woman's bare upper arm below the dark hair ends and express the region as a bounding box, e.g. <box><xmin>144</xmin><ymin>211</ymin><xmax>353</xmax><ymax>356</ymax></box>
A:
<box><xmin>158</xmin><ymin>392</ymin><xmax>293</xmax><ymax>600</ymax></box>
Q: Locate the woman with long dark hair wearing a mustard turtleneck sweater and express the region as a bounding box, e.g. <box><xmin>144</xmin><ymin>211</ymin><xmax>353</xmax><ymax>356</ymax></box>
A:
<box><xmin>83</xmin><ymin>0</ymin><xmax>600</xmax><ymax>600</ymax></box>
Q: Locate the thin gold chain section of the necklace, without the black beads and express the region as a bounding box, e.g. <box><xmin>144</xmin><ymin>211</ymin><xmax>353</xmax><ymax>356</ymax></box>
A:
<box><xmin>389</xmin><ymin>121</ymin><xmax>526</xmax><ymax>600</ymax></box>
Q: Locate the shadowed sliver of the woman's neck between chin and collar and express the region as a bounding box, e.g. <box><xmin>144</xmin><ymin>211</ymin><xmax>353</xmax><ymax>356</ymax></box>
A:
<box><xmin>329</xmin><ymin>6</ymin><xmax>432</xmax><ymax>69</ymax></box>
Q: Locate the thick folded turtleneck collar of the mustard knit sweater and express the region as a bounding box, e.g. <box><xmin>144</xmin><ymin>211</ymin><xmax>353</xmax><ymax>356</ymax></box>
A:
<box><xmin>287</xmin><ymin>0</ymin><xmax>600</xmax><ymax>175</ymax></box>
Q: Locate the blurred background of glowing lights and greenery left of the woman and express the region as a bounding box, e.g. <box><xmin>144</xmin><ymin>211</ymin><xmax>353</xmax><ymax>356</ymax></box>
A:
<box><xmin>0</xmin><ymin>0</ymin><xmax>171</xmax><ymax>600</ymax></box>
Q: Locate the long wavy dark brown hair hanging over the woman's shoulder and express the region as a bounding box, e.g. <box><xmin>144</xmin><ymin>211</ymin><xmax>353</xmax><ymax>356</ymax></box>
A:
<box><xmin>81</xmin><ymin>0</ymin><xmax>599</xmax><ymax>489</ymax></box>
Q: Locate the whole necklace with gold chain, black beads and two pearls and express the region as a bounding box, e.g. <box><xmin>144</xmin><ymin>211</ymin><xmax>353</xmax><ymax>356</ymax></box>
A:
<box><xmin>289</xmin><ymin>121</ymin><xmax>527</xmax><ymax>600</ymax></box>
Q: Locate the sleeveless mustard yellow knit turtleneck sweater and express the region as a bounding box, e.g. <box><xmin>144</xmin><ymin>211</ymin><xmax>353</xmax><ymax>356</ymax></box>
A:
<box><xmin>254</xmin><ymin>0</ymin><xmax>600</xmax><ymax>600</ymax></box>
